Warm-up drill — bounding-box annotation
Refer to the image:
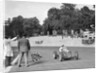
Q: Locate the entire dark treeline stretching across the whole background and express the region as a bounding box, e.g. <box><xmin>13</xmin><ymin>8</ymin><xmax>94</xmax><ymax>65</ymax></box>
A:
<box><xmin>5</xmin><ymin>3</ymin><xmax>95</xmax><ymax>37</ymax></box>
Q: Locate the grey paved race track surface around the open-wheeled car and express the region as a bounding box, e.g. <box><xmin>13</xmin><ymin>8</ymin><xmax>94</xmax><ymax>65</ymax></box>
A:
<box><xmin>7</xmin><ymin>47</ymin><xmax>95</xmax><ymax>72</ymax></box>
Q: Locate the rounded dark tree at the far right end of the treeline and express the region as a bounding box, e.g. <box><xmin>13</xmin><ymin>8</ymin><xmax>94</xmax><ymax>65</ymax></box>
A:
<box><xmin>79</xmin><ymin>6</ymin><xmax>95</xmax><ymax>29</ymax></box>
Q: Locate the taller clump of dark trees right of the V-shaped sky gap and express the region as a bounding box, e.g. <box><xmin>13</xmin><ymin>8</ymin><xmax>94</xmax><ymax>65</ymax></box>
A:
<box><xmin>43</xmin><ymin>3</ymin><xmax>95</xmax><ymax>34</ymax></box>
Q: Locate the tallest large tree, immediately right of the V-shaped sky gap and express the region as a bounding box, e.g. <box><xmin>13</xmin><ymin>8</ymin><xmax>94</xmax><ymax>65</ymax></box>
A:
<box><xmin>43</xmin><ymin>4</ymin><xmax>75</xmax><ymax>34</ymax></box>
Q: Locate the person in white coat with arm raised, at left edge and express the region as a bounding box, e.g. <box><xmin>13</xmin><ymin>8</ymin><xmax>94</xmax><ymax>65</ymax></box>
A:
<box><xmin>4</xmin><ymin>37</ymin><xmax>17</xmax><ymax>67</ymax></box>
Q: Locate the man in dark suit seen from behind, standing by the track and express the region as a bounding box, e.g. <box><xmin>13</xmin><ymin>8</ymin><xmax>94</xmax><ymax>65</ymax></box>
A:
<box><xmin>18</xmin><ymin>34</ymin><xmax>30</xmax><ymax>67</ymax></box>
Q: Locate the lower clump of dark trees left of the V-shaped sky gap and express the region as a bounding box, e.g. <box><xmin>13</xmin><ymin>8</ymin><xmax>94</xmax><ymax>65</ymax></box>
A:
<box><xmin>5</xmin><ymin>16</ymin><xmax>41</xmax><ymax>37</ymax></box>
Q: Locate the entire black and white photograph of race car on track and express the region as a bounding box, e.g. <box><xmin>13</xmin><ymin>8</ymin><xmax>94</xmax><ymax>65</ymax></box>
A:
<box><xmin>3</xmin><ymin>0</ymin><xmax>96</xmax><ymax>72</ymax></box>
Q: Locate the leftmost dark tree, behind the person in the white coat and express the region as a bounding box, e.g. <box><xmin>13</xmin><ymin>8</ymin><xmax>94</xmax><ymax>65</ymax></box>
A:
<box><xmin>4</xmin><ymin>16</ymin><xmax>23</xmax><ymax>37</ymax></box>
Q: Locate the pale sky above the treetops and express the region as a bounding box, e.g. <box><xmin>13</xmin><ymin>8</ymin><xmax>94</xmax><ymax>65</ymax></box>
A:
<box><xmin>5</xmin><ymin>1</ymin><xmax>93</xmax><ymax>24</ymax></box>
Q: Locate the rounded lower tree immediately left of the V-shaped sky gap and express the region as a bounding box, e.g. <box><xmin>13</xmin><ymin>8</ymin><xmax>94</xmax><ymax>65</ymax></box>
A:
<box><xmin>23</xmin><ymin>17</ymin><xmax>41</xmax><ymax>36</ymax></box>
